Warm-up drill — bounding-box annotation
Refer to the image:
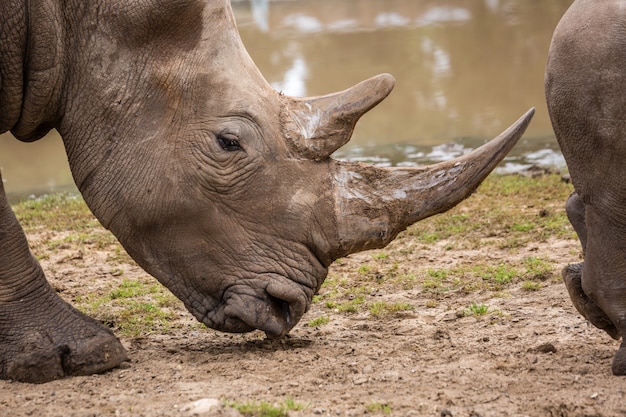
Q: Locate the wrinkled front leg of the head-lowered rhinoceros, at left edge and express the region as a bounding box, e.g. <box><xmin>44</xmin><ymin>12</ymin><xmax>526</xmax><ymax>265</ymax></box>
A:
<box><xmin>0</xmin><ymin>171</ymin><xmax>126</xmax><ymax>383</ymax></box>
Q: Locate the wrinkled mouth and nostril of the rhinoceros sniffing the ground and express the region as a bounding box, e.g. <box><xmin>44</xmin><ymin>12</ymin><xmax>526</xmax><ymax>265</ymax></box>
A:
<box><xmin>218</xmin><ymin>274</ymin><xmax>309</xmax><ymax>339</ymax></box>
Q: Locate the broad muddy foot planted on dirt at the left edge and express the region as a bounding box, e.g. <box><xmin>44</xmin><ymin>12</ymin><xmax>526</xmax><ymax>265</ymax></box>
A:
<box><xmin>0</xmin><ymin>286</ymin><xmax>127</xmax><ymax>383</ymax></box>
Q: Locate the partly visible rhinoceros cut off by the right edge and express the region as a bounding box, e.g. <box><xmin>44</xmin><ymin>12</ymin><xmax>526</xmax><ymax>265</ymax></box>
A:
<box><xmin>545</xmin><ymin>0</ymin><xmax>626</xmax><ymax>375</ymax></box>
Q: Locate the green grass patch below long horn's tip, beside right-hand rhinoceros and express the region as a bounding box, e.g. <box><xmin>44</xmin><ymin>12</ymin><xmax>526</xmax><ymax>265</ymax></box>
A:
<box><xmin>408</xmin><ymin>174</ymin><xmax>574</xmax><ymax>249</ymax></box>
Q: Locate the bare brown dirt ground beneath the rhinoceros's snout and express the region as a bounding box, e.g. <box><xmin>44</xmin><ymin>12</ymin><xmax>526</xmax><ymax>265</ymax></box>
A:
<box><xmin>0</xmin><ymin>199</ymin><xmax>626</xmax><ymax>417</ymax></box>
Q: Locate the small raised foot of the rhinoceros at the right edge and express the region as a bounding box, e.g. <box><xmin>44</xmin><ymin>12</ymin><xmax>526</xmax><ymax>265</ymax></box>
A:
<box><xmin>562</xmin><ymin>262</ymin><xmax>626</xmax><ymax>340</ymax></box>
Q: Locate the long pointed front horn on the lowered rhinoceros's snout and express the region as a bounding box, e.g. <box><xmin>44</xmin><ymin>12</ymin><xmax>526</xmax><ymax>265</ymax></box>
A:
<box><xmin>334</xmin><ymin>108</ymin><xmax>535</xmax><ymax>257</ymax></box>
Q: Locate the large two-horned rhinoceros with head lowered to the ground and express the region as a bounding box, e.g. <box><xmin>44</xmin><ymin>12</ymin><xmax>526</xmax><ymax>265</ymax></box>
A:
<box><xmin>0</xmin><ymin>0</ymin><xmax>533</xmax><ymax>382</ymax></box>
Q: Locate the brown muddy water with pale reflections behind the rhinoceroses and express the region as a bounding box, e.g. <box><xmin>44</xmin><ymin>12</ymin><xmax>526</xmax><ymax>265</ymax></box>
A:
<box><xmin>0</xmin><ymin>0</ymin><xmax>571</xmax><ymax>202</ymax></box>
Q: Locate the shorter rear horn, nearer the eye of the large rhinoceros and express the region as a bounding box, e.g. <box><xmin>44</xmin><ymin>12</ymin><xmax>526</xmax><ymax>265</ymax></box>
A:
<box><xmin>281</xmin><ymin>74</ymin><xmax>395</xmax><ymax>161</ymax></box>
